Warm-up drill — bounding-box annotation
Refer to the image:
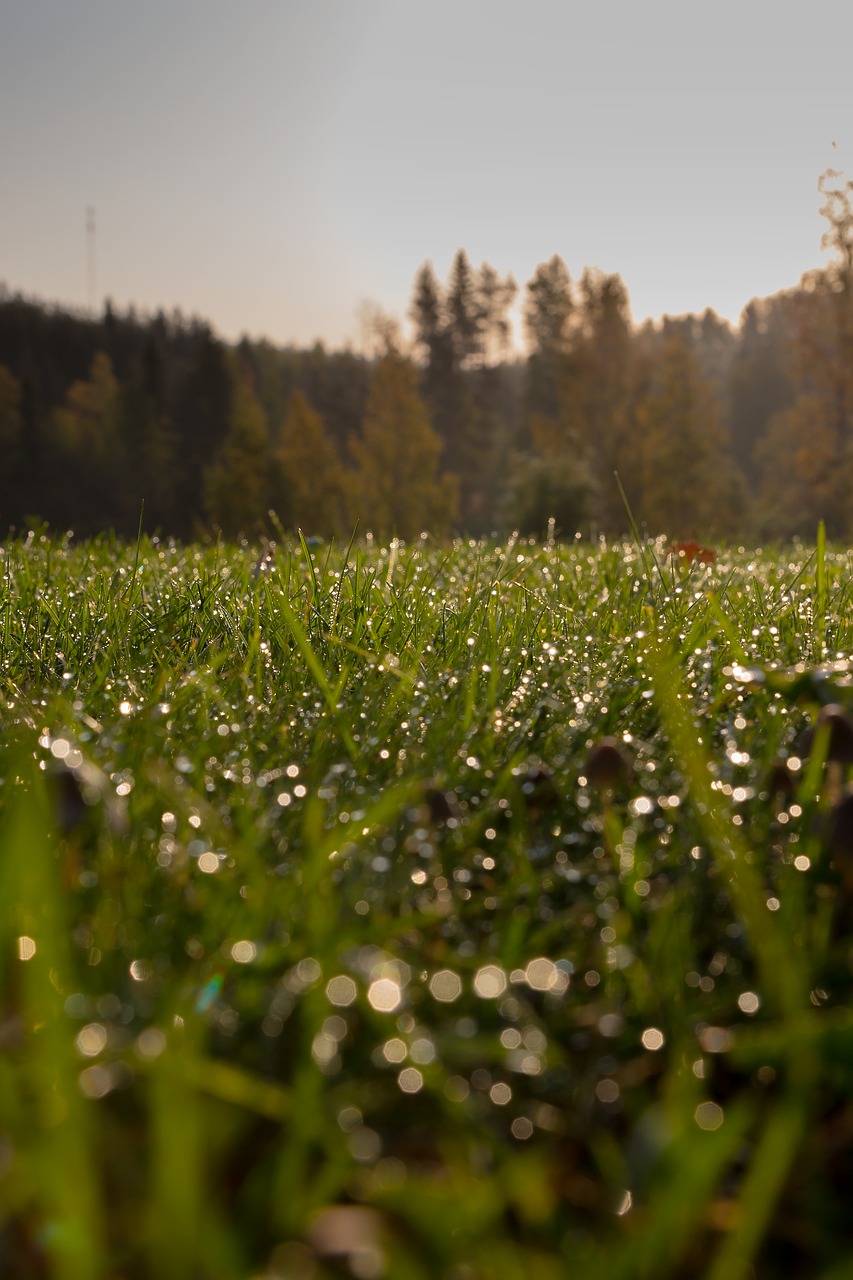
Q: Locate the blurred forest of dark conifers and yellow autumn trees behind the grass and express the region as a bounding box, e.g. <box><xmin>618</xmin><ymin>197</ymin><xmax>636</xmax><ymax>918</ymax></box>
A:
<box><xmin>0</xmin><ymin>170</ymin><xmax>853</xmax><ymax>541</ymax></box>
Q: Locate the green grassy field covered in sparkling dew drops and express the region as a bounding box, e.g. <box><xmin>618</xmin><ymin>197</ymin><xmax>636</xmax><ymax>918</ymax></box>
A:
<box><xmin>0</xmin><ymin>532</ymin><xmax>853</xmax><ymax>1280</ymax></box>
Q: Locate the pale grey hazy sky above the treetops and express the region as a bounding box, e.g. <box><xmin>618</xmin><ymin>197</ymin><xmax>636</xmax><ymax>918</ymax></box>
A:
<box><xmin>0</xmin><ymin>0</ymin><xmax>853</xmax><ymax>346</ymax></box>
